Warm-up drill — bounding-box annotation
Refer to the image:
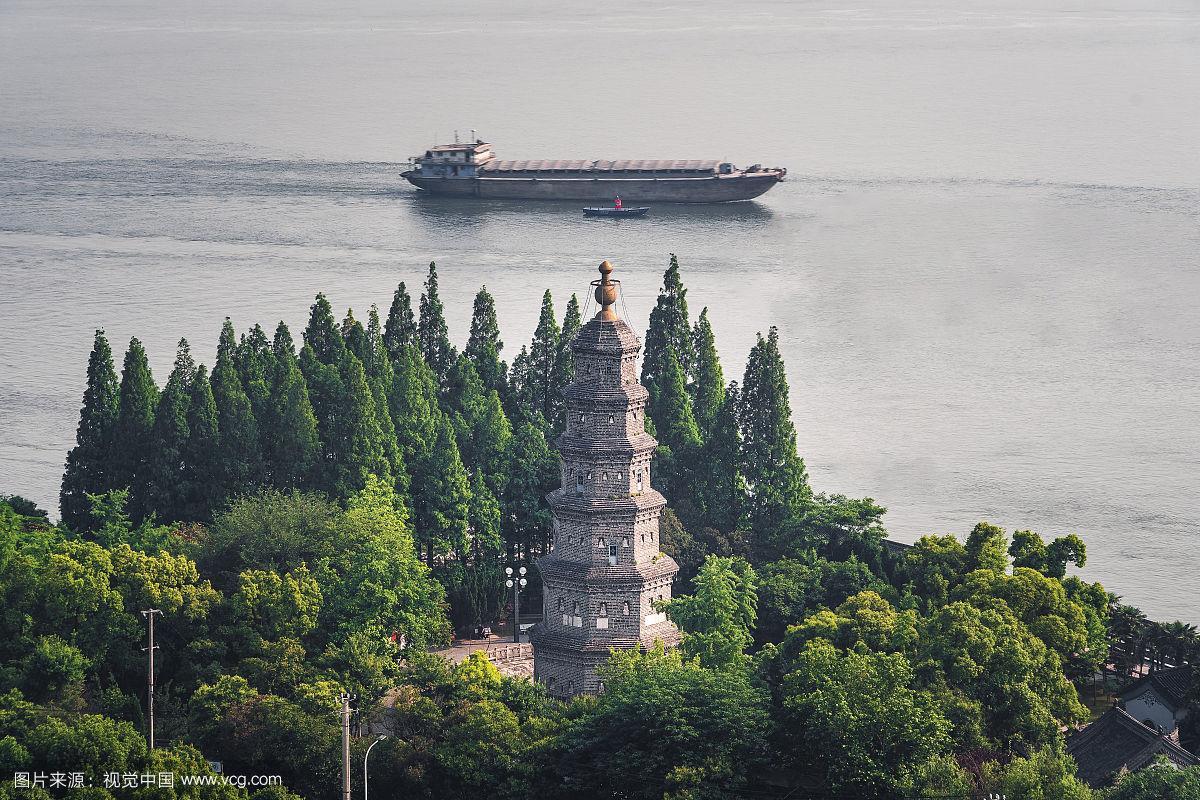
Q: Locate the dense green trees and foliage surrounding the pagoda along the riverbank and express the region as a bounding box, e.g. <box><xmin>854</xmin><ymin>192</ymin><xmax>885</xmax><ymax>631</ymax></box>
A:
<box><xmin>0</xmin><ymin>257</ymin><xmax>1200</xmax><ymax>800</ymax></box>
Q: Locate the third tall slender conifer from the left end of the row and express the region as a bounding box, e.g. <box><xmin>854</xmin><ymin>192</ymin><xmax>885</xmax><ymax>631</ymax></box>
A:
<box><xmin>148</xmin><ymin>339</ymin><xmax>196</xmax><ymax>522</ymax></box>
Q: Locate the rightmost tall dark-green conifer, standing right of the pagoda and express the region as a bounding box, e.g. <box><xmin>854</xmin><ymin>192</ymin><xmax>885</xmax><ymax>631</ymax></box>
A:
<box><xmin>738</xmin><ymin>326</ymin><xmax>811</xmax><ymax>541</ymax></box>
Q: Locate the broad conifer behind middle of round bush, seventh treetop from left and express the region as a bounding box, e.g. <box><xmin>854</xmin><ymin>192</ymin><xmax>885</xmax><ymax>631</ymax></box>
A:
<box><xmin>259</xmin><ymin>323</ymin><xmax>320</xmax><ymax>489</ymax></box>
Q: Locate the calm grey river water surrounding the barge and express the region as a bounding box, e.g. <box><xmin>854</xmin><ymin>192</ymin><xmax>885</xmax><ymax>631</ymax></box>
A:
<box><xmin>0</xmin><ymin>0</ymin><xmax>1200</xmax><ymax>622</ymax></box>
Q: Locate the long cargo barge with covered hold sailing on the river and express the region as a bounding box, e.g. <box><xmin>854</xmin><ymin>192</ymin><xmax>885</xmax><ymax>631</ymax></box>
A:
<box><xmin>401</xmin><ymin>142</ymin><xmax>787</xmax><ymax>203</ymax></box>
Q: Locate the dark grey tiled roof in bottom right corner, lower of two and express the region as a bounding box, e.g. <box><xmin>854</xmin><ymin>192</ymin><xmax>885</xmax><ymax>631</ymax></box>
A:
<box><xmin>1067</xmin><ymin>708</ymin><xmax>1200</xmax><ymax>788</ymax></box>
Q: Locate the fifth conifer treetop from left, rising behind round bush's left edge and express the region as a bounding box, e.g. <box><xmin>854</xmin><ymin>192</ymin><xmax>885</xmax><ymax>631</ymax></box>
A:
<box><xmin>211</xmin><ymin>317</ymin><xmax>263</xmax><ymax>499</ymax></box>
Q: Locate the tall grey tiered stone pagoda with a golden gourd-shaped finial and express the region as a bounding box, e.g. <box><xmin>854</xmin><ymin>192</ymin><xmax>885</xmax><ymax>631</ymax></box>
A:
<box><xmin>530</xmin><ymin>261</ymin><xmax>679</xmax><ymax>697</ymax></box>
